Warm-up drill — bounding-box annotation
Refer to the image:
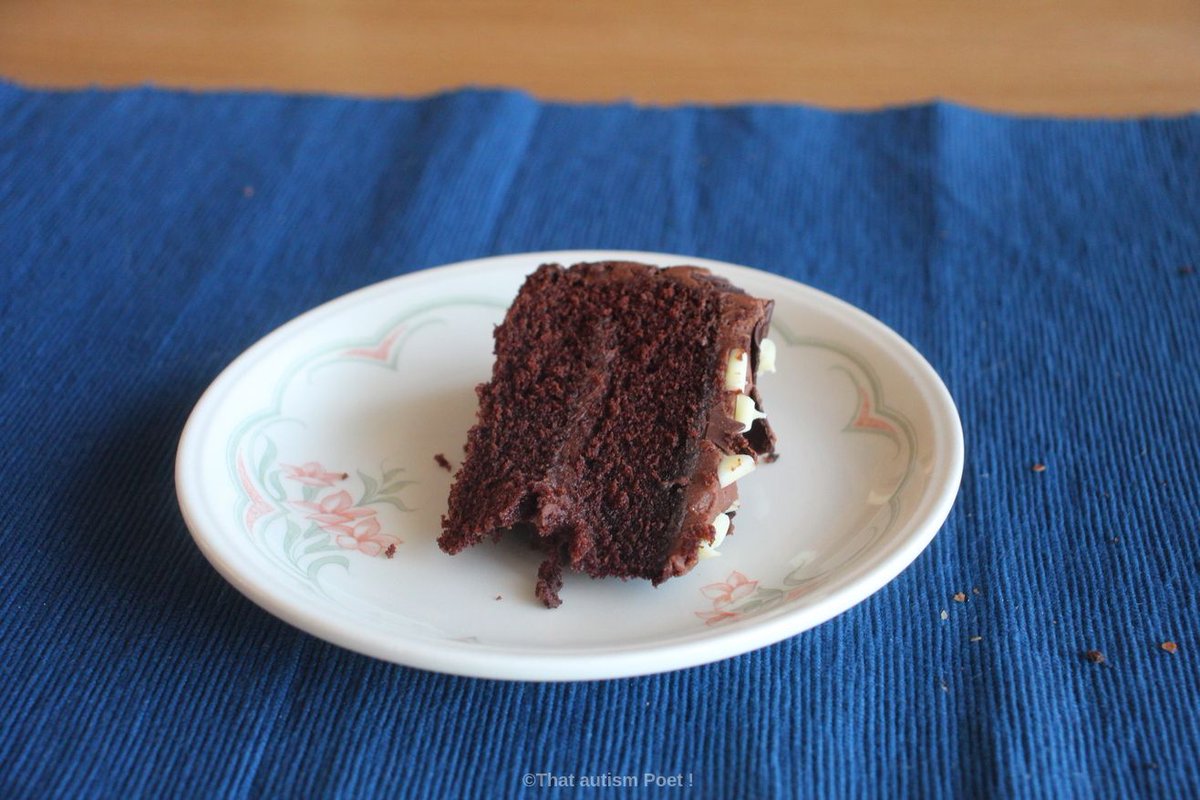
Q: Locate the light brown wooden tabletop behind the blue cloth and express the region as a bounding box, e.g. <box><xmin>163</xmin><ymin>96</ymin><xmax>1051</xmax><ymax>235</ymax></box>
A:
<box><xmin>0</xmin><ymin>0</ymin><xmax>1200</xmax><ymax>115</ymax></box>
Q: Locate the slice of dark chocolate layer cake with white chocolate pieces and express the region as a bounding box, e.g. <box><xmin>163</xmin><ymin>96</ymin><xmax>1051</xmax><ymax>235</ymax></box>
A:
<box><xmin>438</xmin><ymin>261</ymin><xmax>775</xmax><ymax>607</ymax></box>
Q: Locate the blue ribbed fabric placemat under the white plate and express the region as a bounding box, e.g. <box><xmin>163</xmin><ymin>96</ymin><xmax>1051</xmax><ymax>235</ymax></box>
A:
<box><xmin>0</xmin><ymin>84</ymin><xmax>1200</xmax><ymax>798</ymax></box>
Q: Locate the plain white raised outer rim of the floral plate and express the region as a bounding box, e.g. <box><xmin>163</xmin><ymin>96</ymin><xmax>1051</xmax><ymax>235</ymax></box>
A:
<box><xmin>174</xmin><ymin>249</ymin><xmax>965</xmax><ymax>681</ymax></box>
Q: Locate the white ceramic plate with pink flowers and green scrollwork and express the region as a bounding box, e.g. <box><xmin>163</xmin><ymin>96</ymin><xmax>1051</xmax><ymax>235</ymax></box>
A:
<box><xmin>175</xmin><ymin>251</ymin><xmax>962</xmax><ymax>680</ymax></box>
